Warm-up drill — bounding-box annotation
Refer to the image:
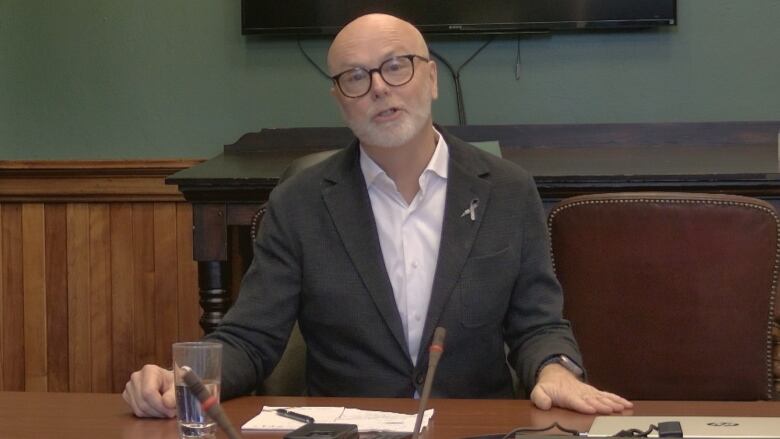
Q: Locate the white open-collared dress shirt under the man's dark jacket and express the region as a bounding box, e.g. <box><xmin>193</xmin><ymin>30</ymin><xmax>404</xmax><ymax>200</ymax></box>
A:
<box><xmin>360</xmin><ymin>132</ymin><xmax>449</xmax><ymax>364</ymax></box>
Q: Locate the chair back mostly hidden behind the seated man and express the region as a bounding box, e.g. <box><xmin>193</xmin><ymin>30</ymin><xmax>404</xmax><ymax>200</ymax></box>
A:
<box><xmin>250</xmin><ymin>150</ymin><xmax>338</xmax><ymax>396</ymax></box>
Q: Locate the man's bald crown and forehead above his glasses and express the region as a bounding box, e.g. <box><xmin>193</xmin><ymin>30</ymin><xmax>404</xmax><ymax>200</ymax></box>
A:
<box><xmin>328</xmin><ymin>14</ymin><xmax>430</xmax><ymax>75</ymax></box>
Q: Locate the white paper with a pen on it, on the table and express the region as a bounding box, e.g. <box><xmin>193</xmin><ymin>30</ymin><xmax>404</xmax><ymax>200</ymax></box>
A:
<box><xmin>241</xmin><ymin>407</ymin><xmax>433</xmax><ymax>433</ymax></box>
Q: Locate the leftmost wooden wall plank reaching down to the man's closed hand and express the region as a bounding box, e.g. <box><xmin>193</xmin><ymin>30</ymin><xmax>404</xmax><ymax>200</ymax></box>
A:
<box><xmin>110</xmin><ymin>203</ymin><xmax>140</xmax><ymax>392</ymax></box>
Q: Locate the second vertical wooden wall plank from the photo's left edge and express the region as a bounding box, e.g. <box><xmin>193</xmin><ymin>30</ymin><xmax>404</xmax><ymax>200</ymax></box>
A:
<box><xmin>22</xmin><ymin>203</ymin><xmax>48</xmax><ymax>392</ymax></box>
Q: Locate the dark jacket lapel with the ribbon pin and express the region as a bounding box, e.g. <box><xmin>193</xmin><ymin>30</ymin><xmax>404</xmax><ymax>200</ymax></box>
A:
<box><xmin>417</xmin><ymin>135</ymin><xmax>490</xmax><ymax>366</ymax></box>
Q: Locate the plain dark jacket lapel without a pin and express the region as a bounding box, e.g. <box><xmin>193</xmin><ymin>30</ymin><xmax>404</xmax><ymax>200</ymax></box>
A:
<box><xmin>322</xmin><ymin>142</ymin><xmax>411</xmax><ymax>362</ymax></box>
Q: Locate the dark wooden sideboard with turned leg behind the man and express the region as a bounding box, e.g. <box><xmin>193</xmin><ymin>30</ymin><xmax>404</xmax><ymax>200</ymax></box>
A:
<box><xmin>166</xmin><ymin>121</ymin><xmax>780</xmax><ymax>332</ymax></box>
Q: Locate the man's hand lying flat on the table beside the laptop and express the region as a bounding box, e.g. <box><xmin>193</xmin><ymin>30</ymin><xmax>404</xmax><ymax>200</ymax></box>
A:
<box><xmin>531</xmin><ymin>363</ymin><xmax>634</xmax><ymax>415</ymax></box>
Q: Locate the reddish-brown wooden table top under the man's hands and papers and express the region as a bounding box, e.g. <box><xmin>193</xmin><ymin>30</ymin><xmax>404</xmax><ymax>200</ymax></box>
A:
<box><xmin>0</xmin><ymin>392</ymin><xmax>780</xmax><ymax>439</ymax></box>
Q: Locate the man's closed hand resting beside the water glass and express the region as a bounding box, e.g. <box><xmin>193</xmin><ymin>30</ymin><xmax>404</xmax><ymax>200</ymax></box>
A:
<box><xmin>122</xmin><ymin>364</ymin><xmax>176</xmax><ymax>418</ymax></box>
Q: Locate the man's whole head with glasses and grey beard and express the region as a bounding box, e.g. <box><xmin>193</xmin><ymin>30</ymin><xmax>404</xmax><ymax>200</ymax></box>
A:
<box><xmin>328</xmin><ymin>14</ymin><xmax>438</xmax><ymax>155</ymax></box>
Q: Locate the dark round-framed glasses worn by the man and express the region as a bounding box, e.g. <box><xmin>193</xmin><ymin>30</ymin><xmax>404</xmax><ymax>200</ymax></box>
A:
<box><xmin>330</xmin><ymin>55</ymin><xmax>430</xmax><ymax>98</ymax></box>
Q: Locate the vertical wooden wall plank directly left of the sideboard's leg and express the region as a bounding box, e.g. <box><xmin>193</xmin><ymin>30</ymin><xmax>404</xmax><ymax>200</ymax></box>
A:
<box><xmin>176</xmin><ymin>203</ymin><xmax>203</xmax><ymax>341</ymax></box>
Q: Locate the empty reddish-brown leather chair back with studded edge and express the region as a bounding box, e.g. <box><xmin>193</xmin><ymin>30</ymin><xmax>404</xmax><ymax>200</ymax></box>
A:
<box><xmin>548</xmin><ymin>193</ymin><xmax>780</xmax><ymax>400</ymax></box>
